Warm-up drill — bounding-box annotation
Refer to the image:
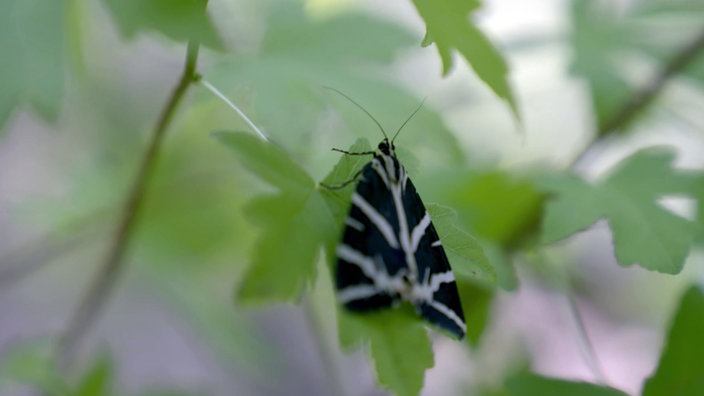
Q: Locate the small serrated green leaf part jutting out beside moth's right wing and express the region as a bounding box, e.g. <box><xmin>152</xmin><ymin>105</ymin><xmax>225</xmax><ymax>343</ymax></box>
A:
<box><xmin>425</xmin><ymin>203</ymin><xmax>496</xmax><ymax>284</ymax></box>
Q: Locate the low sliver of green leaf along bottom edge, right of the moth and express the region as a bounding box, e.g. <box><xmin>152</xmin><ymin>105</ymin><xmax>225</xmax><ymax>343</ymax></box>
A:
<box><xmin>506</xmin><ymin>374</ymin><xmax>627</xmax><ymax>396</ymax></box>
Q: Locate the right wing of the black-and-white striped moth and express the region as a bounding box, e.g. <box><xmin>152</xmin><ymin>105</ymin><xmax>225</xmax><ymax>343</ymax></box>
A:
<box><xmin>403</xmin><ymin>179</ymin><xmax>467</xmax><ymax>339</ymax></box>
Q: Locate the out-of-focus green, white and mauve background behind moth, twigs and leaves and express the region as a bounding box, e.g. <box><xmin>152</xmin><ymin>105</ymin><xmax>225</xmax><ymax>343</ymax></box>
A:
<box><xmin>0</xmin><ymin>0</ymin><xmax>704</xmax><ymax>395</ymax></box>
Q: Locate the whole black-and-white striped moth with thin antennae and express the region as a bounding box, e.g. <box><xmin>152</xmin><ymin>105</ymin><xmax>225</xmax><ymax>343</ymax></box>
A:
<box><xmin>336</xmin><ymin>92</ymin><xmax>467</xmax><ymax>339</ymax></box>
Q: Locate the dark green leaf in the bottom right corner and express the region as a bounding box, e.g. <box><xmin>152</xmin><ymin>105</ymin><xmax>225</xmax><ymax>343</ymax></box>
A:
<box><xmin>643</xmin><ymin>286</ymin><xmax>704</xmax><ymax>396</ymax></box>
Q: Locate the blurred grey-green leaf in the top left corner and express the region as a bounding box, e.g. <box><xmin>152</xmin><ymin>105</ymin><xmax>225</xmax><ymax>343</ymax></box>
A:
<box><xmin>0</xmin><ymin>0</ymin><xmax>68</xmax><ymax>126</ymax></box>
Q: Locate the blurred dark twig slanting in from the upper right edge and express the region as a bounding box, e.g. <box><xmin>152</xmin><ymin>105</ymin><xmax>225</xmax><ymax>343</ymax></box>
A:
<box><xmin>568</xmin><ymin>29</ymin><xmax>704</xmax><ymax>168</ymax></box>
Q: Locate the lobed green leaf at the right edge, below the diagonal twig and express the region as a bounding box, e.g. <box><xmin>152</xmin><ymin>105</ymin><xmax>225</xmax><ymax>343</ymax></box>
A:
<box><xmin>542</xmin><ymin>147</ymin><xmax>697</xmax><ymax>274</ymax></box>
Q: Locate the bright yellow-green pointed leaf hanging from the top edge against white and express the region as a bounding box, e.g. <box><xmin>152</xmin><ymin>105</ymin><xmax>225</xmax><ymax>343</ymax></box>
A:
<box><xmin>413</xmin><ymin>0</ymin><xmax>518</xmax><ymax>118</ymax></box>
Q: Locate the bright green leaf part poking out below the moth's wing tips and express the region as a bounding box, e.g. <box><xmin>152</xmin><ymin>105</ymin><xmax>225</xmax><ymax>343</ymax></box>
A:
<box><xmin>338</xmin><ymin>309</ymin><xmax>433</xmax><ymax>395</ymax></box>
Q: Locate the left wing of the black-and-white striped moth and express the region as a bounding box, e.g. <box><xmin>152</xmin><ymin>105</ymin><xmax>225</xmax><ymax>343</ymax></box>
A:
<box><xmin>336</xmin><ymin>163</ymin><xmax>407</xmax><ymax>311</ymax></box>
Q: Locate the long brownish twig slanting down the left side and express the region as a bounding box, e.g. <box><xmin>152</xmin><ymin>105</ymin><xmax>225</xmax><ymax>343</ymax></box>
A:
<box><xmin>57</xmin><ymin>42</ymin><xmax>199</xmax><ymax>369</ymax></box>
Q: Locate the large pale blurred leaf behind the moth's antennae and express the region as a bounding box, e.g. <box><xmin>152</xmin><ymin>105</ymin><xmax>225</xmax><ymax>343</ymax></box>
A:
<box><xmin>205</xmin><ymin>2</ymin><xmax>462</xmax><ymax>165</ymax></box>
